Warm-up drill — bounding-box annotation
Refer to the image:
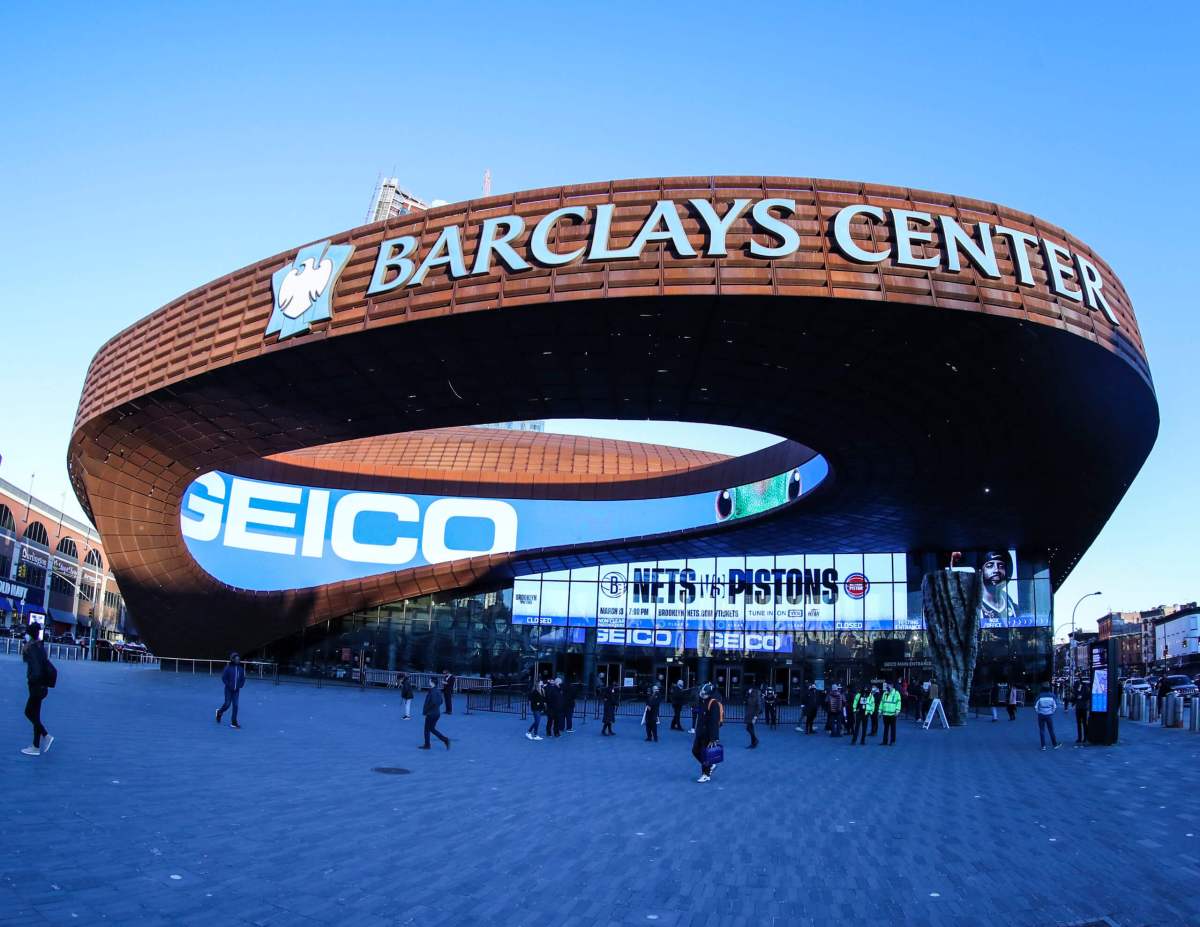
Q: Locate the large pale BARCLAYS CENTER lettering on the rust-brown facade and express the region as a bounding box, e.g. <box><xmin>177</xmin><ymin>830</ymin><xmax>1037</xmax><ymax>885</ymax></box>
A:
<box><xmin>367</xmin><ymin>197</ymin><xmax>1121</xmax><ymax>325</ymax></box>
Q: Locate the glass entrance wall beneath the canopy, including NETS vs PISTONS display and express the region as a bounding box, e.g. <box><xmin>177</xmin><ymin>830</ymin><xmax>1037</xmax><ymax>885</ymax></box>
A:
<box><xmin>253</xmin><ymin>554</ymin><xmax>1052</xmax><ymax>702</ymax></box>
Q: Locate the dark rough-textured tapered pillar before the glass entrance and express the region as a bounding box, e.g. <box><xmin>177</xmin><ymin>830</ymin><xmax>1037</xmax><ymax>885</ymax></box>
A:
<box><xmin>920</xmin><ymin>569</ymin><xmax>983</xmax><ymax>724</ymax></box>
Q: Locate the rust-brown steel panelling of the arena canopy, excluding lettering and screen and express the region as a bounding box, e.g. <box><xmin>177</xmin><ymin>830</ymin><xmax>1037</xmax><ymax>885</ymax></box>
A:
<box><xmin>68</xmin><ymin>177</ymin><xmax>1158</xmax><ymax>653</ymax></box>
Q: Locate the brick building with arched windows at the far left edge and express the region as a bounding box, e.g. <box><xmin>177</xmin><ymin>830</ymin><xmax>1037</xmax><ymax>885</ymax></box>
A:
<box><xmin>0</xmin><ymin>479</ymin><xmax>132</xmax><ymax>640</ymax></box>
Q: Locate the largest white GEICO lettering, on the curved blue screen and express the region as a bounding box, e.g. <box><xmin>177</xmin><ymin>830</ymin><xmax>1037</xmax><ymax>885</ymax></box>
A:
<box><xmin>181</xmin><ymin>473</ymin><xmax>517</xmax><ymax>566</ymax></box>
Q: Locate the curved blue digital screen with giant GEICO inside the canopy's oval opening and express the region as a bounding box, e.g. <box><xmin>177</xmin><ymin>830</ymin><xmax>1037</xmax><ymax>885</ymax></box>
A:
<box><xmin>180</xmin><ymin>455</ymin><xmax>829</xmax><ymax>593</ymax></box>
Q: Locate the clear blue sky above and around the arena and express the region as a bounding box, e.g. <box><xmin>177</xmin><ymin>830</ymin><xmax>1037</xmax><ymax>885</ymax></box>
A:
<box><xmin>0</xmin><ymin>2</ymin><xmax>1200</xmax><ymax>638</ymax></box>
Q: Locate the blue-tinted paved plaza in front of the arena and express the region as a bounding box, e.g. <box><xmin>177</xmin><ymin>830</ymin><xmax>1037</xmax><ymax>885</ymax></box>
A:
<box><xmin>0</xmin><ymin>657</ymin><xmax>1200</xmax><ymax>927</ymax></box>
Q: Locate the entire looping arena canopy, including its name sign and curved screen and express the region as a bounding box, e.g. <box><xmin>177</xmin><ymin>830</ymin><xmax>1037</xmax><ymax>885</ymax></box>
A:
<box><xmin>68</xmin><ymin>177</ymin><xmax>1158</xmax><ymax>656</ymax></box>
